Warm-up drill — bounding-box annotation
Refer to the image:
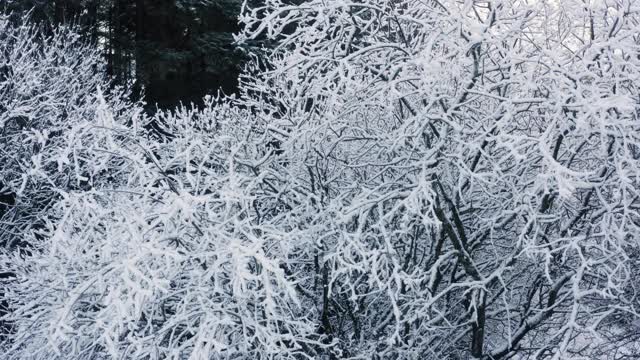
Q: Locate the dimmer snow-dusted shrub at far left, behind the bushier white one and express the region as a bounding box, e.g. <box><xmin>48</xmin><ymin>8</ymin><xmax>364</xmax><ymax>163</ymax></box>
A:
<box><xmin>0</xmin><ymin>16</ymin><xmax>140</xmax><ymax>248</ymax></box>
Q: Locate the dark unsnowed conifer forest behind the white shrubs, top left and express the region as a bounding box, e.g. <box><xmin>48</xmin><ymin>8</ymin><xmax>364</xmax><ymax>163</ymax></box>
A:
<box><xmin>4</xmin><ymin>0</ymin><xmax>242</xmax><ymax>110</ymax></box>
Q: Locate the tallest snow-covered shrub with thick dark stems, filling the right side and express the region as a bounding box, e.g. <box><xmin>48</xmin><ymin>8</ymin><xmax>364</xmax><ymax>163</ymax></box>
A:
<box><xmin>239</xmin><ymin>0</ymin><xmax>640</xmax><ymax>359</ymax></box>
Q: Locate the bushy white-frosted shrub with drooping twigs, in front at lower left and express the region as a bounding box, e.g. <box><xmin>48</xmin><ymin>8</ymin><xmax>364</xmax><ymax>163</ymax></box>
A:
<box><xmin>2</xmin><ymin>94</ymin><xmax>314</xmax><ymax>359</ymax></box>
